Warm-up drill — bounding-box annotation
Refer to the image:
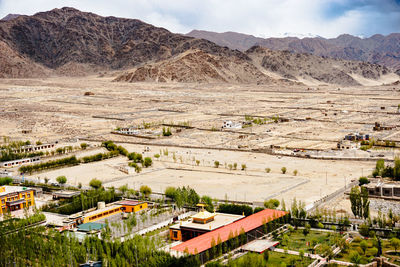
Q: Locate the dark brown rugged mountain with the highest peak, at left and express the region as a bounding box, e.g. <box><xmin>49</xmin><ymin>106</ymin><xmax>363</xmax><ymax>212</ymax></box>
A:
<box><xmin>0</xmin><ymin>7</ymin><xmax>246</xmax><ymax>72</ymax></box>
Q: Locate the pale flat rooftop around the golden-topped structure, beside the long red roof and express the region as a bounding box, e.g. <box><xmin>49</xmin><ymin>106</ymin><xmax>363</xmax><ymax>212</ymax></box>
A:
<box><xmin>170</xmin><ymin>213</ymin><xmax>244</xmax><ymax>231</ymax></box>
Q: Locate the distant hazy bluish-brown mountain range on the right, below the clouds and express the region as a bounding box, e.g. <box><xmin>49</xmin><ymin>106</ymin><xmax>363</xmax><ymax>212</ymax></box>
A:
<box><xmin>187</xmin><ymin>31</ymin><xmax>400</xmax><ymax>70</ymax></box>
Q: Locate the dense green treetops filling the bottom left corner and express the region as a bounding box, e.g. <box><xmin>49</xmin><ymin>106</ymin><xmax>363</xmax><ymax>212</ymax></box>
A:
<box><xmin>0</xmin><ymin>227</ymin><xmax>200</xmax><ymax>267</ymax></box>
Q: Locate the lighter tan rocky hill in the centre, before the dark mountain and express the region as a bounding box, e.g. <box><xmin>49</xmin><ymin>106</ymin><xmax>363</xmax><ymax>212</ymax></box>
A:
<box><xmin>115</xmin><ymin>49</ymin><xmax>273</xmax><ymax>84</ymax></box>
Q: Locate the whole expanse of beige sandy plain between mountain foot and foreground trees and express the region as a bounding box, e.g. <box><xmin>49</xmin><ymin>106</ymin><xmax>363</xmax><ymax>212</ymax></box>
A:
<box><xmin>0</xmin><ymin>77</ymin><xmax>400</xmax><ymax>207</ymax></box>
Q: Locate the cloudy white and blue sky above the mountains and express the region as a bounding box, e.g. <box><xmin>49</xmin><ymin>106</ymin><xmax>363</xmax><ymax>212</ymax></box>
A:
<box><xmin>0</xmin><ymin>0</ymin><xmax>400</xmax><ymax>38</ymax></box>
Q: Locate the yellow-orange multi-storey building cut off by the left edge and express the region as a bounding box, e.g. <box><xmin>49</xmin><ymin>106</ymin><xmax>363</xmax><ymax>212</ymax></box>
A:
<box><xmin>0</xmin><ymin>186</ymin><xmax>35</xmax><ymax>214</ymax></box>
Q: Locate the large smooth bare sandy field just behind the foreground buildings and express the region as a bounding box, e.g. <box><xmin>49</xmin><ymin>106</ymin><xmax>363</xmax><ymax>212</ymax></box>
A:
<box><xmin>27</xmin><ymin>143</ymin><xmax>374</xmax><ymax>204</ymax></box>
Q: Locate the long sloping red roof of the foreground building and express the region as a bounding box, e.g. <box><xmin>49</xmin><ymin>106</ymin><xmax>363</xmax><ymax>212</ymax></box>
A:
<box><xmin>171</xmin><ymin>209</ymin><xmax>288</xmax><ymax>254</ymax></box>
